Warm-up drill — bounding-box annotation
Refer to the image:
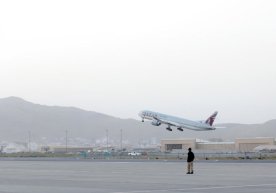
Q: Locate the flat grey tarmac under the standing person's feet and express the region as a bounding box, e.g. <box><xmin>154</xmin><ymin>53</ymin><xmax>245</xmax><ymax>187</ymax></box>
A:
<box><xmin>0</xmin><ymin>160</ymin><xmax>276</xmax><ymax>193</ymax></box>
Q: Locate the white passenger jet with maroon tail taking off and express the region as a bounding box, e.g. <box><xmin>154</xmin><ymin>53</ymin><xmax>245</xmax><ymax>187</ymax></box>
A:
<box><xmin>138</xmin><ymin>110</ymin><xmax>218</xmax><ymax>131</ymax></box>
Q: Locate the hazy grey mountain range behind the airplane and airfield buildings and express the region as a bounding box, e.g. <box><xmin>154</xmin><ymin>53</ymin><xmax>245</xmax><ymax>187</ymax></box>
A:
<box><xmin>0</xmin><ymin>97</ymin><xmax>276</xmax><ymax>144</ymax></box>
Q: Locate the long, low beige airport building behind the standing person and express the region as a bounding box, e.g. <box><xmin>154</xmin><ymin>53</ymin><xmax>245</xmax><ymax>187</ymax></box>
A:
<box><xmin>161</xmin><ymin>137</ymin><xmax>276</xmax><ymax>152</ymax></box>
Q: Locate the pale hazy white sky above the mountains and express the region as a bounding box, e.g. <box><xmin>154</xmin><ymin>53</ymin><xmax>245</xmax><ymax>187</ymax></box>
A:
<box><xmin>0</xmin><ymin>0</ymin><xmax>276</xmax><ymax>123</ymax></box>
